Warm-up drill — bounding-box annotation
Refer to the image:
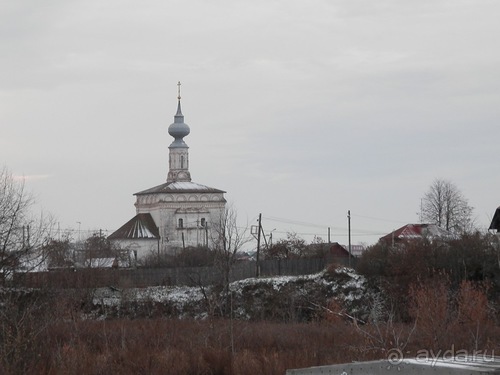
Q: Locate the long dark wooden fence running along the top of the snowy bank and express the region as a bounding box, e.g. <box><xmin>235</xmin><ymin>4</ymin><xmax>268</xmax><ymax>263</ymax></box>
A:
<box><xmin>15</xmin><ymin>258</ymin><xmax>352</xmax><ymax>288</ymax></box>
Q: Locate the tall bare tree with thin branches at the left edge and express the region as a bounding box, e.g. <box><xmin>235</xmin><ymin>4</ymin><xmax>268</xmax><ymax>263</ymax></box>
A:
<box><xmin>0</xmin><ymin>168</ymin><xmax>53</xmax><ymax>278</ymax></box>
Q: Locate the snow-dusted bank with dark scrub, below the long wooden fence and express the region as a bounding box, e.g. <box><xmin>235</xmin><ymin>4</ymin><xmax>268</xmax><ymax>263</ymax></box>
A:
<box><xmin>87</xmin><ymin>268</ymin><xmax>374</xmax><ymax>321</ymax></box>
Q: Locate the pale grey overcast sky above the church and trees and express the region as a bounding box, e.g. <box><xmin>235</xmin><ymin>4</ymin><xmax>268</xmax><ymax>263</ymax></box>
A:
<box><xmin>0</xmin><ymin>0</ymin><xmax>500</xmax><ymax>248</ymax></box>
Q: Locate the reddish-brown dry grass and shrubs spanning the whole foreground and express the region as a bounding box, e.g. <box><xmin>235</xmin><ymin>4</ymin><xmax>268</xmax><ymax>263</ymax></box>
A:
<box><xmin>0</xmin><ymin>258</ymin><xmax>500</xmax><ymax>375</ymax></box>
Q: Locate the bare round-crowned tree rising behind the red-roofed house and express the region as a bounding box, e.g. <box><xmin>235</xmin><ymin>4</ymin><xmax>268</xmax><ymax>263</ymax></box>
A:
<box><xmin>421</xmin><ymin>179</ymin><xmax>474</xmax><ymax>233</ymax></box>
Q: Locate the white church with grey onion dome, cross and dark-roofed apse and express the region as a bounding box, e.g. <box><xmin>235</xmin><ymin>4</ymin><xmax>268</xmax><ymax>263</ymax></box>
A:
<box><xmin>109</xmin><ymin>82</ymin><xmax>226</xmax><ymax>259</ymax></box>
